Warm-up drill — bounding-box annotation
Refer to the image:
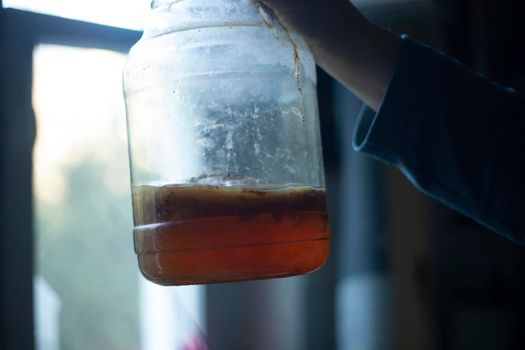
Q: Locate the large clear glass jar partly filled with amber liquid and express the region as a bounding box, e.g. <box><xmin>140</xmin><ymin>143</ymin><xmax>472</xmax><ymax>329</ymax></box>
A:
<box><xmin>124</xmin><ymin>0</ymin><xmax>330</xmax><ymax>285</ymax></box>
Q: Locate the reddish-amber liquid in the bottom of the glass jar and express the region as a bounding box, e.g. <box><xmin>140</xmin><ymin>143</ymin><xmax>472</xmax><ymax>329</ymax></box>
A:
<box><xmin>133</xmin><ymin>185</ymin><xmax>330</xmax><ymax>285</ymax></box>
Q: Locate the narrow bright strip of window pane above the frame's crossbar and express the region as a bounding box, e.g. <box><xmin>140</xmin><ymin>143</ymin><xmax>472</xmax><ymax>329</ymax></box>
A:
<box><xmin>2</xmin><ymin>0</ymin><xmax>150</xmax><ymax>29</ymax></box>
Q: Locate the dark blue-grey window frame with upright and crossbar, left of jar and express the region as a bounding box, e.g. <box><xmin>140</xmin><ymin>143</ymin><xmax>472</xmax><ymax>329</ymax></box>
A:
<box><xmin>0</xmin><ymin>4</ymin><xmax>141</xmax><ymax>350</ymax></box>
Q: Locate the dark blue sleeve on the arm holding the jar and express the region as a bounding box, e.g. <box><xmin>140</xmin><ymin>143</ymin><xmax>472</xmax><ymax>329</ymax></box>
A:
<box><xmin>354</xmin><ymin>37</ymin><xmax>525</xmax><ymax>244</ymax></box>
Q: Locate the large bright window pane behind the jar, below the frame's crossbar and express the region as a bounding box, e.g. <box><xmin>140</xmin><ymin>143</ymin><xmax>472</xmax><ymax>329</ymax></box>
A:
<box><xmin>33</xmin><ymin>45</ymin><xmax>204</xmax><ymax>349</ymax></box>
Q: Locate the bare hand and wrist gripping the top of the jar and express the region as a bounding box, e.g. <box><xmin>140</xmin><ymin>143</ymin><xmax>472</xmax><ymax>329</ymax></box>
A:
<box><xmin>255</xmin><ymin>0</ymin><xmax>400</xmax><ymax>111</ymax></box>
